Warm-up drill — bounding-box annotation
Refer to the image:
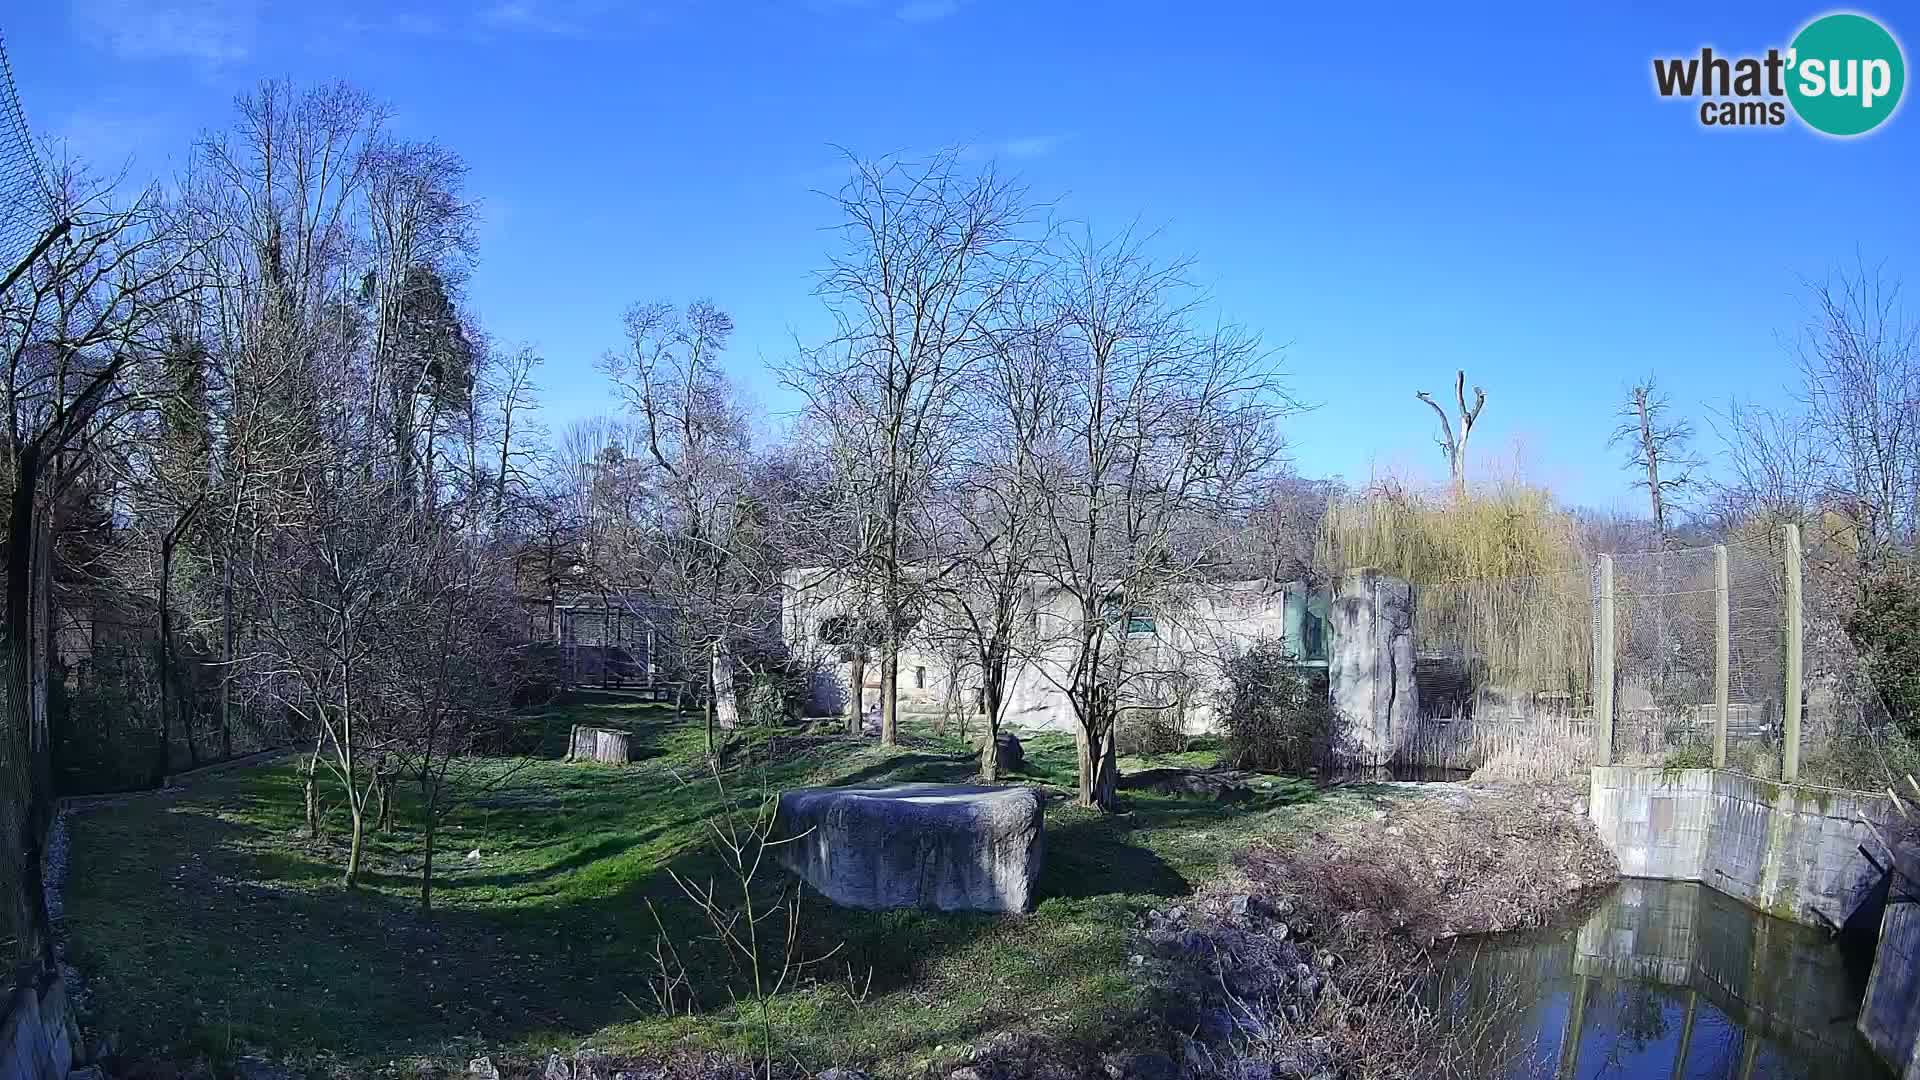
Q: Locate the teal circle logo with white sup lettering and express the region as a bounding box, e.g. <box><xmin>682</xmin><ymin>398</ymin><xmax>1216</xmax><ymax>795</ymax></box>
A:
<box><xmin>1788</xmin><ymin>12</ymin><xmax>1907</xmax><ymax>136</ymax></box>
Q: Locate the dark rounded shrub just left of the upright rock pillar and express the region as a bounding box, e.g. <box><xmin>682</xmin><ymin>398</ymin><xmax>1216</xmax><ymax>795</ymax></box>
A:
<box><xmin>1219</xmin><ymin>638</ymin><xmax>1344</xmax><ymax>773</ymax></box>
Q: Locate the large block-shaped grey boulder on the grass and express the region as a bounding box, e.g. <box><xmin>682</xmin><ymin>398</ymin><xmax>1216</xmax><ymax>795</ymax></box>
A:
<box><xmin>774</xmin><ymin>784</ymin><xmax>1044</xmax><ymax>911</ymax></box>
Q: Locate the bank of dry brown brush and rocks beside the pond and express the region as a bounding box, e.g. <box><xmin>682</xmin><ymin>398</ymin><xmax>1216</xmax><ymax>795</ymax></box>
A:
<box><xmin>1135</xmin><ymin>784</ymin><xmax>1619</xmax><ymax>1080</ymax></box>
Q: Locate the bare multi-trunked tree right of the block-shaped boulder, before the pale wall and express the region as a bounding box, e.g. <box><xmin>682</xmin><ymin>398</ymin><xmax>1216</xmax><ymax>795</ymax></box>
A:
<box><xmin>1035</xmin><ymin>234</ymin><xmax>1292</xmax><ymax>807</ymax></box>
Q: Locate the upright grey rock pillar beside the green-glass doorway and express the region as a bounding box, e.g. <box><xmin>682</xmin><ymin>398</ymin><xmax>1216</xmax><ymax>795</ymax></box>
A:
<box><xmin>1327</xmin><ymin>569</ymin><xmax>1421</xmax><ymax>765</ymax></box>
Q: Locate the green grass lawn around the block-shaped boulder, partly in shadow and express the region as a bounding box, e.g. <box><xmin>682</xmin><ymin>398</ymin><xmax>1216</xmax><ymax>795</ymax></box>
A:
<box><xmin>67</xmin><ymin>701</ymin><xmax>1348</xmax><ymax>1074</ymax></box>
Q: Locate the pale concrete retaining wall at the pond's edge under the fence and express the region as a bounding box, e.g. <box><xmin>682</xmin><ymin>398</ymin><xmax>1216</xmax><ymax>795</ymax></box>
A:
<box><xmin>1590</xmin><ymin>765</ymin><xmax>1895</xmax><ymax>924</ymax></box>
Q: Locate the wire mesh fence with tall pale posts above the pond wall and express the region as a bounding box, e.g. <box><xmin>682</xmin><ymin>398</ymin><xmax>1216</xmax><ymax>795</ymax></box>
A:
<box><xmin>1398</xmin><ymin>525</ymin><xmax>1820</xmax><ymax>780</ymax></box>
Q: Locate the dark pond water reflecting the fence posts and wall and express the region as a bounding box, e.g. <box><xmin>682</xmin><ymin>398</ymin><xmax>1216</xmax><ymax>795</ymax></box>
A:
<box><xmin>1438</xmin><ymin>880</ymin><xmax>1891</xmax><ymax>1080</ymax></box>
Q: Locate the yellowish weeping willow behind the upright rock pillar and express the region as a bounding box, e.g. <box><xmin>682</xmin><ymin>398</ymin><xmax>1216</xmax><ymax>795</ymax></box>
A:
<box><xmin>1315</xmin><ymin>486</ymin><xmax>1594</xmax><ymax>700</ymax></box>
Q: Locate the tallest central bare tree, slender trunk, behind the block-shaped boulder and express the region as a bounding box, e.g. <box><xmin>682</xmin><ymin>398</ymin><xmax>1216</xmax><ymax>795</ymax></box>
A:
<box><xmin>785</xmin><ymin>152</ymin><xmax>1029</xmax><ymax>746</ymax></box>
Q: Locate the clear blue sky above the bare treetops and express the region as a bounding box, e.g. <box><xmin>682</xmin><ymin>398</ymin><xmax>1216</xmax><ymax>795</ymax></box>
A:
<box><xmin>0</xmin><ymin>0</ymin><xmax>1920</xmax><ymax>507</ymax></box>
